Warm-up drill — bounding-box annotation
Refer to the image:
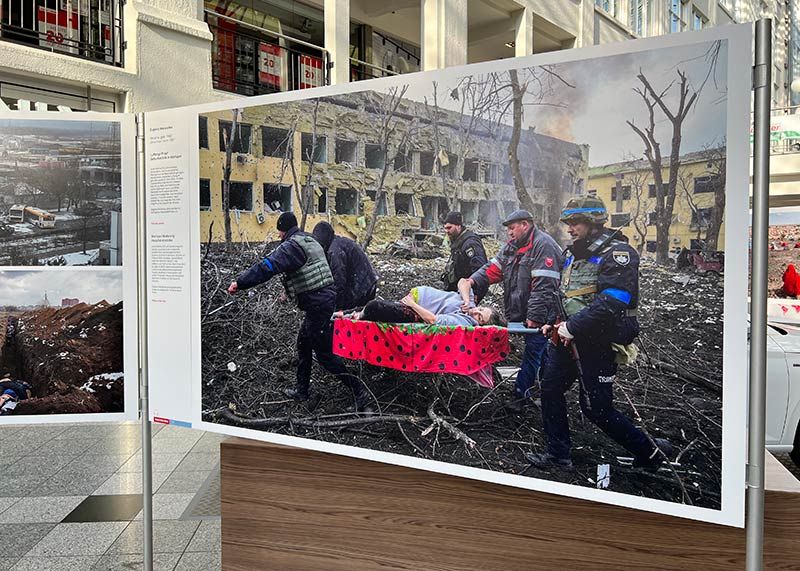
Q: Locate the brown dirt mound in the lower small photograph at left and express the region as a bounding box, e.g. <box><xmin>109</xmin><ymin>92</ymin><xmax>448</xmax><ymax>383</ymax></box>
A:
<box><xmin>13</xmin><ymin>301</ymin><xmax>124</xmax><ymax>414</ymax></box>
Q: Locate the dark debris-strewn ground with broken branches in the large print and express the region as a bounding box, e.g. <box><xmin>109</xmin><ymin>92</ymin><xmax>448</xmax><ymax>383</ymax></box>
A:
<box><xmin>201</xmin><ymin>245</ymin><xmax>723</xmax><ymax>508</ymax></box>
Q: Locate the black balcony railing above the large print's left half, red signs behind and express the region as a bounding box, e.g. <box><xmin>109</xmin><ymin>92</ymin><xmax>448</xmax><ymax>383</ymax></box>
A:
<box><xmin>205</xmin><ymin>10</ymin><xmax>330</xmax><ymax>95</ymax></box>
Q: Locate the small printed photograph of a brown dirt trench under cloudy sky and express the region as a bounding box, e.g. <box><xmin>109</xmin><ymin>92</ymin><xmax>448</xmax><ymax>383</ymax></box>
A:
<box><xmin>0</xmin><ymin>269</ymin><xmax>125</xmax><ymax>419</ymax></box>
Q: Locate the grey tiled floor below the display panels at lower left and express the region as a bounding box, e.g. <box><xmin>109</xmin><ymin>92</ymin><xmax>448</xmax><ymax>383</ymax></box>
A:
<box><xmin>0</xmin><ymin>422</ymin><xmax>224</xmax><ymax>571</ymax></box>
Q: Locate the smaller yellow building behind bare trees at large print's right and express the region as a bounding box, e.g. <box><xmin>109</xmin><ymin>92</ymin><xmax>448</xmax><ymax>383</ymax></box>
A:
<box><xmin>586</xmin><ymin>149</ymin><xmax>725</xmax><ymax>255</ymax></box>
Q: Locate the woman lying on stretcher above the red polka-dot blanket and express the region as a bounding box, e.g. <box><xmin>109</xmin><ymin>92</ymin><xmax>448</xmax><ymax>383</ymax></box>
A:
<box><xmin>334</xmin><ymin>286</ymin><xmax>507</xmax><ymax>327</ymax></box>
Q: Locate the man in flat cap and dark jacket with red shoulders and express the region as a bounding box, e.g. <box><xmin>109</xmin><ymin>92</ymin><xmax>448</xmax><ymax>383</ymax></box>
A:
<box><xmin>462</xmin><ymin>210</ymin><xmax>562</xmax><ymax>412</ymax></box>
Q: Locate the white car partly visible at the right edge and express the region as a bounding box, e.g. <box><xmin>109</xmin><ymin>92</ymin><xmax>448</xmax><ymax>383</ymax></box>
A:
<box><xmin>766</xmin><ymin>322</ymin><xmax>800</xmax><ymax>466</ymax></box>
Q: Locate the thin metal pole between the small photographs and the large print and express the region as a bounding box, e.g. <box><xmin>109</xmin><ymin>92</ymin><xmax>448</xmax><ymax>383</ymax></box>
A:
<box><xmin>136</xmin><ymin>113</ymin><xmax>153</xmax><ymax>571</ymax></box>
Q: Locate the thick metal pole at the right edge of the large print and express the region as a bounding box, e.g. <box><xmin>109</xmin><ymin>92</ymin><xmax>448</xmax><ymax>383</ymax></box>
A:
<box><xmin>746</xmin><ymin>18</ymin><xmax>772</xmax><ymax>571</ymax></box>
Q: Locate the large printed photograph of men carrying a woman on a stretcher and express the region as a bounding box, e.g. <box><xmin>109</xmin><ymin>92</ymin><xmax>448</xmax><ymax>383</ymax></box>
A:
<box><xmin>198</xmin><ymin>41</ymin><xmax>745</xmax><ymax>510</ymax></box>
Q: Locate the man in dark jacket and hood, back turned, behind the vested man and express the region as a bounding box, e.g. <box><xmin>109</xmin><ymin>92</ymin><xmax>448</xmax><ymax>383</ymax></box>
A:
<box><xmin>313</xmin><ymin>222</ymin><xmax>378</xmax><ymax>309</ymax></box>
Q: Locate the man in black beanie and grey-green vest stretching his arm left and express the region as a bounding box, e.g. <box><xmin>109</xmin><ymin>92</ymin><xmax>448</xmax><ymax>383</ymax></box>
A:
<box><xmin>228</xmin><ymin>212</ymin><xmax>372</xmax><ymax>412</ymax></box>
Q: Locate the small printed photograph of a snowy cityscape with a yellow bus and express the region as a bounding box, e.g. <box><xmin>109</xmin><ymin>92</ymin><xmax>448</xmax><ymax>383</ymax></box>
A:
<box><xmin>0</xmin><ymin>118</ymin><xmax>122</xmax><ymax>266</ymax></box>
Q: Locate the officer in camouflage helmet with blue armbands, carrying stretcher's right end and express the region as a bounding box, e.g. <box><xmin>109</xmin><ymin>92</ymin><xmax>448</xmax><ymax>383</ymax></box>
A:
<box><xmin>526</xmin><ymin>196</ymin><xmax>672</xmax><ymax>469</ymax></box>
